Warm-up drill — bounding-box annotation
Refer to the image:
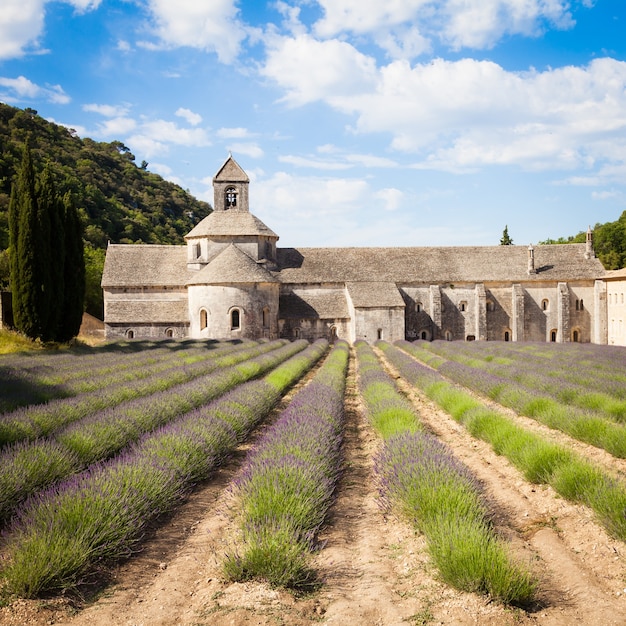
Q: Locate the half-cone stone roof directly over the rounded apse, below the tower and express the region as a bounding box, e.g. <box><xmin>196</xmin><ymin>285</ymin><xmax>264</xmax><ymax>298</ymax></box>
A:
<box><xmin>186</xmin><ymin>244</ymin><xmax>278</xmax><ymax>285</ymax></box>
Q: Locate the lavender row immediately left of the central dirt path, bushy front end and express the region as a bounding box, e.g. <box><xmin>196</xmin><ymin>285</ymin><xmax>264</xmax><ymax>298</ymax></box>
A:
<box><xmin>224</xmin><ymin>342</ymin><xmax>349</xmax><ymax>588</ymax></box>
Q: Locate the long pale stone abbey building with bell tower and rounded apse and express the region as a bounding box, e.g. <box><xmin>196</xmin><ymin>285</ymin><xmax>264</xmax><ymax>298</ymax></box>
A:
<box><xmin>102</xmin><ymin>156</ymin><xmax>608</xmax><ymax>343</ymax></box>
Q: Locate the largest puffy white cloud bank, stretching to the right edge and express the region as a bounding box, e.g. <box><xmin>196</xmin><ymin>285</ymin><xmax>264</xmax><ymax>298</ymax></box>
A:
<box><xmin>264</xmin><ymin>36</ymin><xmax>626</xmax><ymax>171</ymax></box>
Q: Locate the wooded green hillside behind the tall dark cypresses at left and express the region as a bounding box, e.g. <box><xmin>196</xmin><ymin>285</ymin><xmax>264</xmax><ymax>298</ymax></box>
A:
<box><xmin>0</xmin><ymin>103</ymin><xmax>211</xmax><ymax>318</ymax></box>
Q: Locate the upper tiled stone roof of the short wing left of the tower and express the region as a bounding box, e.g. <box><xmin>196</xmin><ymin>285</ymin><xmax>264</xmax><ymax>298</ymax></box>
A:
<box><xmin>102</xmin><ymin>244</ymin><xmax>188</xmax><ymax>288</ymax></box>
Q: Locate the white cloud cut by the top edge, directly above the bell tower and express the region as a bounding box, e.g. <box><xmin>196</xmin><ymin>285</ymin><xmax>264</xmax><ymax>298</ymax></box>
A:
<box><xmin>143</xmin><ymin>0</ymin><xmax>246</xmax><ymax>63</ymax></box>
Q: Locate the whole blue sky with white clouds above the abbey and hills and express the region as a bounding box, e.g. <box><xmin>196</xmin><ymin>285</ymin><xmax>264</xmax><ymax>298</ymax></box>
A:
<box><xmin>0</xmin><ymin>0</ymin><xmax>626</xmax><ymax>246</ymax></box>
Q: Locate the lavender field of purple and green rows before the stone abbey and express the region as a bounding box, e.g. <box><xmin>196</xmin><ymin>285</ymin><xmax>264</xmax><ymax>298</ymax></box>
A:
<box><xmin>0</xmin><ymin>340</ymin><xmax>626</xmax><ymax>626</ymax></box>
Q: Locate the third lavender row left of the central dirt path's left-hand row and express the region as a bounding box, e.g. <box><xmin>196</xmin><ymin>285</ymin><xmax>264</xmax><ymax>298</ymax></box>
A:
<box><xmin>0</xmin><ymin>341</ymin><xmax>278</xmax><ymax>447</ymax></box>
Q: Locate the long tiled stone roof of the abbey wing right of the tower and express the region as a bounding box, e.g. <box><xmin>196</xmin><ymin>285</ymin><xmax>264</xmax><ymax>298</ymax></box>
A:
<box><xmin>276</xmin><ymin>244</ymin><xmax>606</xmax><ymax>284</ymax></box>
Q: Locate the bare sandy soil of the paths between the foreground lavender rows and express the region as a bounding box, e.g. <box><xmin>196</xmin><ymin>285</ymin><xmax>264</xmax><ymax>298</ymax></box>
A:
<box><xmin>0</xmin><ymin>348</ymin><xmax>626</xmax><ymax>626</ymax></box>
